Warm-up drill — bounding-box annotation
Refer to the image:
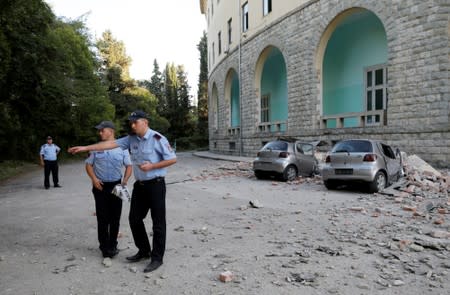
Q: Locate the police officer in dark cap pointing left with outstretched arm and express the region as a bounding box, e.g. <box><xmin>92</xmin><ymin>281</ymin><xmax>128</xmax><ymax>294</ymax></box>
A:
<box><xmin>69</xmin><ymin>110</ymin><xmax>177</xmax><ymax>272</ymax></box>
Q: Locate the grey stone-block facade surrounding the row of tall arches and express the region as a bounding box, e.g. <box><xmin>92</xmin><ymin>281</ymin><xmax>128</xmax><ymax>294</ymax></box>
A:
<box><xmin>209</xmin><ymin>0</ymin><xmax>450</xmax><ymax>167</ymax></box>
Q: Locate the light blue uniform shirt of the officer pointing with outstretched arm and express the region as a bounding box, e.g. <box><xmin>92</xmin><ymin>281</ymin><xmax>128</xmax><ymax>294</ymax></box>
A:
<box><xmin>116</xmin><ymin>128</ymin><xmax>177</xmax><ymax>181</ymax></box>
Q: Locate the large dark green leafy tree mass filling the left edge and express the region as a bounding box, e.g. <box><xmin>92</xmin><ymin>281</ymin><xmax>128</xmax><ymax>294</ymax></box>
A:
<box><xmin>0</xmin><ymin>0</ymin><xmax>114</xmax><ymax>159</ymax></box>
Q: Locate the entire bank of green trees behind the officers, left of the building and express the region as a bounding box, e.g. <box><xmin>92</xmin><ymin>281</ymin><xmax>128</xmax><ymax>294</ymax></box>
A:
<box><xmin>0</xmin><ymin>0</ymin><xmax>207</xmax><ymax>161</ymax></box>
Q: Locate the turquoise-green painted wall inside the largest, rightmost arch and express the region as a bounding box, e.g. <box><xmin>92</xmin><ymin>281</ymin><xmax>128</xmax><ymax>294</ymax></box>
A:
<box><xmin>323</xmin><ymin>10</ymin><xmax>387</xmax><ymax>128</ymax></box>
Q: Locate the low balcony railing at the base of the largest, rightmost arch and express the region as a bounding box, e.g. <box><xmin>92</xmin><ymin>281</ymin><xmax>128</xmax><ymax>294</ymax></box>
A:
<box><xmin>320</xmin><ymin>110</ymin><xmax>386</xmax><ymax>129</ymax></box>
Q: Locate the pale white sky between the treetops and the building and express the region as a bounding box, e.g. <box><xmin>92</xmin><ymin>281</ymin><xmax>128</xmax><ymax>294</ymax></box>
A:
<box><xmin>45</xmin><ymin>0</ymin><xmax>206</xmax><ymax>98</ymax></box>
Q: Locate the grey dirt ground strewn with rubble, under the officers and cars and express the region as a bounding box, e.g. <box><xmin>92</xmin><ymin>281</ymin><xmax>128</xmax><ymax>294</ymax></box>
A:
<box><xmin>0</xmin><ymin>153</ymin><xmax>450</xmax><ymax>295</ymax></box>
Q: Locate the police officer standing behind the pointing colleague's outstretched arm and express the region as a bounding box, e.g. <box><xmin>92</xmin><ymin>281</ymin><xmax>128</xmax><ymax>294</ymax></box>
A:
<box><xmin>85</xmin><ymin>121</ymin><xmax>132</xmax><ymax>258</ymax></box>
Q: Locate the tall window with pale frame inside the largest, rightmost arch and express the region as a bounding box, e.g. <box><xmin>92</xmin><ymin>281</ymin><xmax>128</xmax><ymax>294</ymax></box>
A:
<box><xmin>364</xmin><ymin>65</ymin><xmax>387</xmax><ymax>125</ymax></box>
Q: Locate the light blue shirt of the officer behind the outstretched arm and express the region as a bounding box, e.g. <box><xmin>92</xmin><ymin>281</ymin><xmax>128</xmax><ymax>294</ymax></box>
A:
<box><xmin>85</xmin><ymin>148</ymin><xmax>131</xmax><ymax>182</ymax></box>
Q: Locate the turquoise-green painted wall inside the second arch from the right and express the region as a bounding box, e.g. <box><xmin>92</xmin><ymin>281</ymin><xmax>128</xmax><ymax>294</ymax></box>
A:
<box><xmin>261</xmin><ymin>48</ymin><xmax>288</xmax><ymax>131</ymax></box>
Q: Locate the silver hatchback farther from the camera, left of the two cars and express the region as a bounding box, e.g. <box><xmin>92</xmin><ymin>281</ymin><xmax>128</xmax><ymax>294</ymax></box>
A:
<box><xmin>253</xmin><ymin>139</ymin><xmax>318</xmax><ymax>181</ymax></box>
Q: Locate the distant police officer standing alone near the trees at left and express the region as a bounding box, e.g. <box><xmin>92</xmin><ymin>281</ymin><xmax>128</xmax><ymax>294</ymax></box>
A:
<box><xmin>39</xmin><ymin>136</ymin><xmax>61</xmax><ymax>189</ymax></box>
